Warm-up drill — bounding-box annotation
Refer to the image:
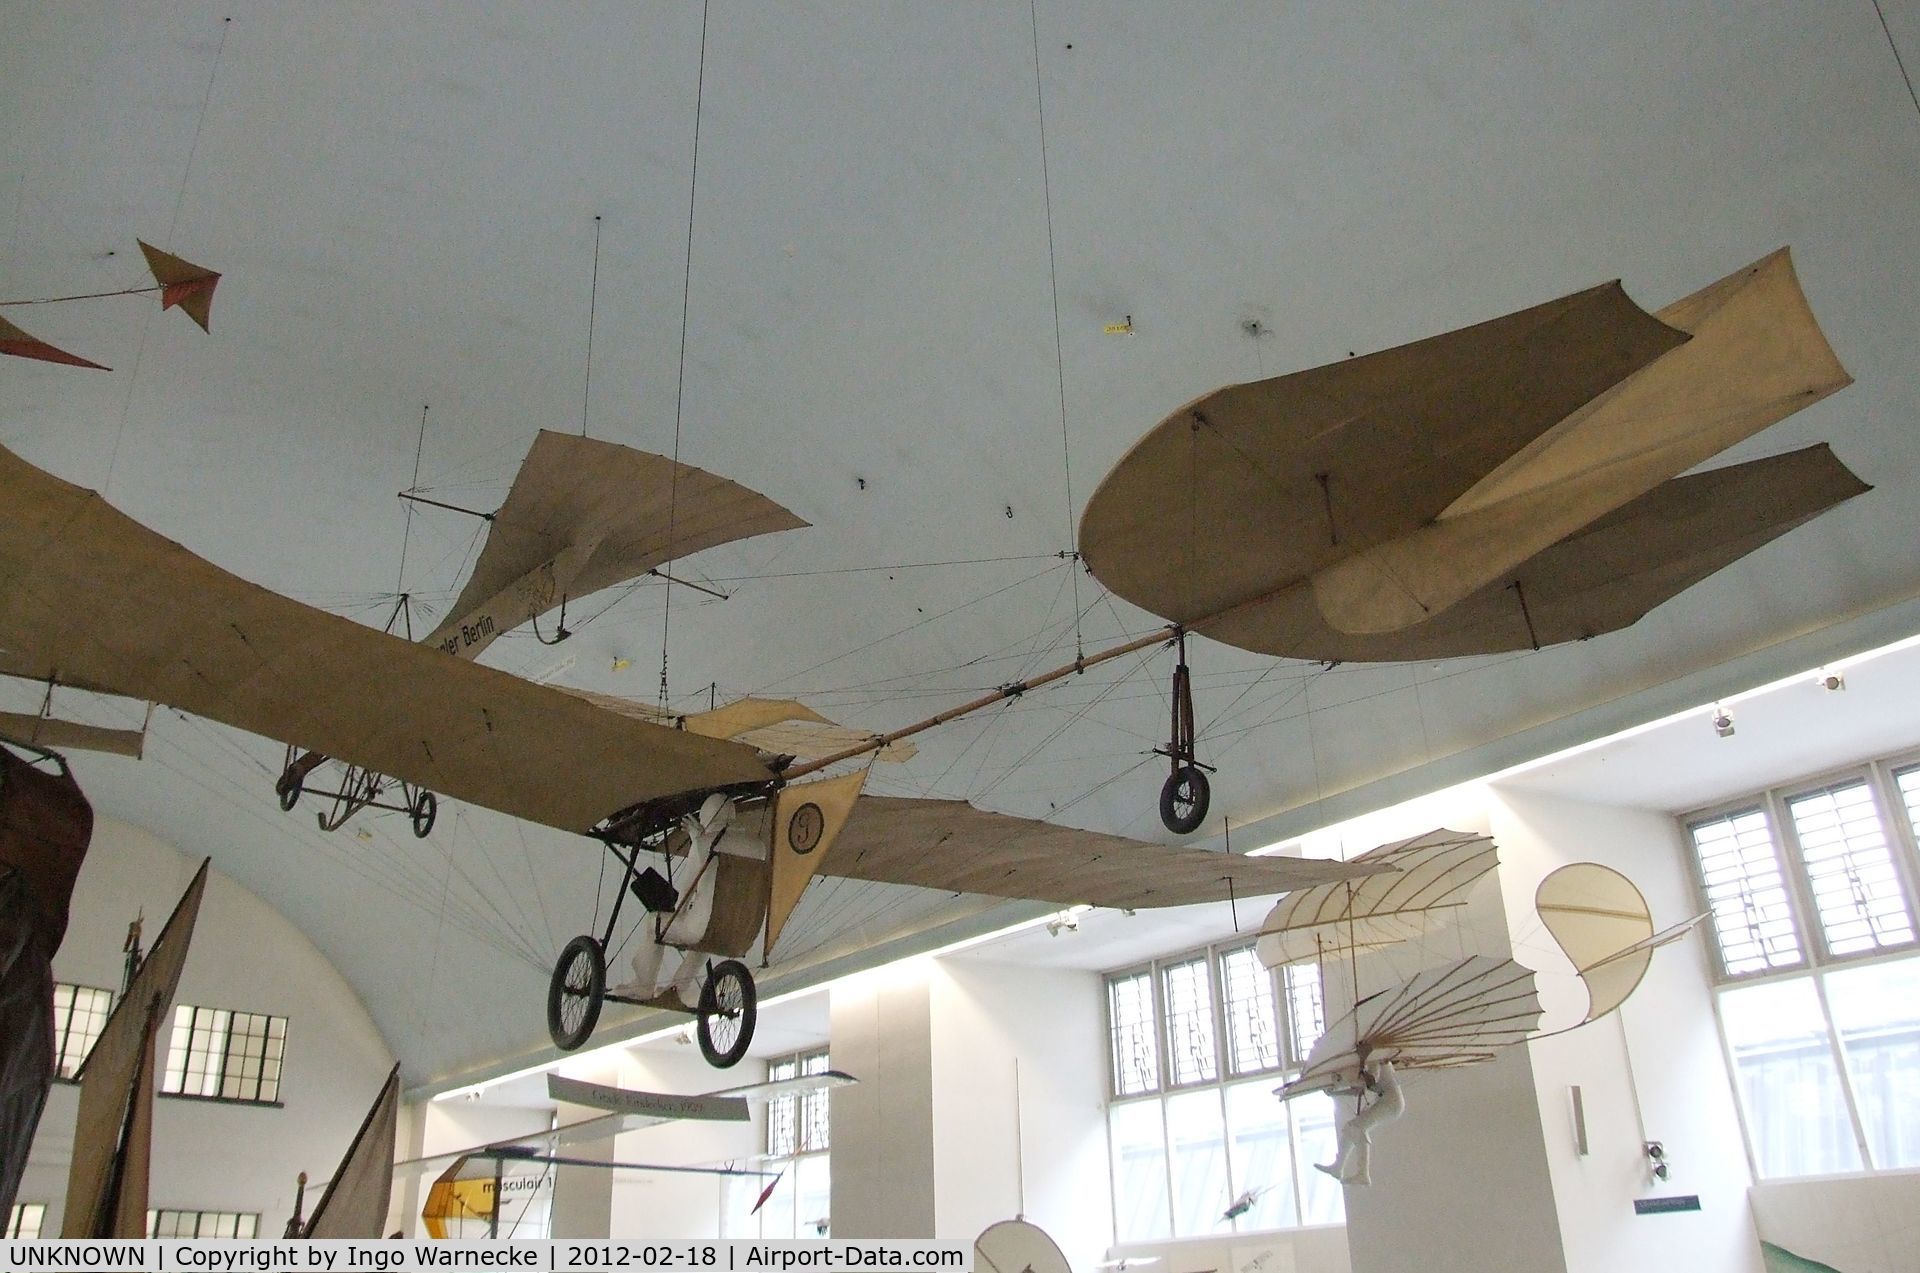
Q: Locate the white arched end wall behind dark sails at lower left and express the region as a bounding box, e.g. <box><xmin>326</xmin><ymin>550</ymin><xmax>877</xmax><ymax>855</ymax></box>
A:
<box><xmin>19</xmin><ymin>818</ymin><xmax>394</xmax><ymax>1237</ymax></box>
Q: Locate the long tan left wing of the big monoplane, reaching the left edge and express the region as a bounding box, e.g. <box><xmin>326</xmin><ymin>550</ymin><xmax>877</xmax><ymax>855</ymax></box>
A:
<box><xmin>0</xmin><ymin>447</ymin><xmax>770</xmax><ymax>831</ymax></box>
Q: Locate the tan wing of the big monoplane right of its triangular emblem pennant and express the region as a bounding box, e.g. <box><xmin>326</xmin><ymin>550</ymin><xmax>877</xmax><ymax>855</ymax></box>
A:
<box><xmin>820</xmin><ymin>795</ymin><xmax>1386</xmax><ymax>908</ymax></box>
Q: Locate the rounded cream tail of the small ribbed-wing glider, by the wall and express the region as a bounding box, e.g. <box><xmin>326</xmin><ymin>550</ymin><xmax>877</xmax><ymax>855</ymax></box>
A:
<box><xmin>1534</xmin><ymin>862</ymin><xmax>1707</xmax><ymax>1033</ymax></box>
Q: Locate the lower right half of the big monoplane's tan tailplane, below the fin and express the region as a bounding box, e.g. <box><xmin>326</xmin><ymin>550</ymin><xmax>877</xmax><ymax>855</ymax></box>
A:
<box><xmin>1204</xmin><ymin>444</ymin><xmax>1872</xmax><ymax>662</ymax></box>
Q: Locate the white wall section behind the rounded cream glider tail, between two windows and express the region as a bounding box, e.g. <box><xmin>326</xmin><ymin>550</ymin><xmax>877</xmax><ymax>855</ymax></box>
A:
<box><xmin>1488</xmin><ymin>785</ymin><xmax>1763</xmax><ymax>1273</ymax></box>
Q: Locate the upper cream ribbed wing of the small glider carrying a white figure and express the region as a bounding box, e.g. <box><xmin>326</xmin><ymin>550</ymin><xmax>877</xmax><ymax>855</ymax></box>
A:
<box><xmin>1254</xmin><ymin>829</ymin><xmax>1500</xmax><ymax>968</ymax></box>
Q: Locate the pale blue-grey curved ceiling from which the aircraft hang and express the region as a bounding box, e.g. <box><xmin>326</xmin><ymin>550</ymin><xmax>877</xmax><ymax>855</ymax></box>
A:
<box><xmin>11</xmin><ymin>0</ymin><xmax>1920</xmax><ymax>1081</ymax></box>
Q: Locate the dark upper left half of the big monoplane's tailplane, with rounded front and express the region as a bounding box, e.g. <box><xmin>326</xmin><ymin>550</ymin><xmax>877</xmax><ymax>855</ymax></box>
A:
<box><xmin>1079</xmin><ymin>284</ymin><xmax>1686</xmax><ymax>633</ymax></box>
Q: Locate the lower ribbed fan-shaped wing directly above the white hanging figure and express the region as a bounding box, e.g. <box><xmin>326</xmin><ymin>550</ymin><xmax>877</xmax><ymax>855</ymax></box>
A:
<box><xmin>1279</xmin><ymin>954</ymin><xmax>1540</xmax><ymax>1100</ymax></box>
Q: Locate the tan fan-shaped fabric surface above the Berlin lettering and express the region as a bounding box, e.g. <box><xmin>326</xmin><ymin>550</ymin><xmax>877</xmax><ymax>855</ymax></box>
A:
<box><xmin>447</xmin><ymin>430</ymin><xmax>806</xmax><ymax>616</ymax></box>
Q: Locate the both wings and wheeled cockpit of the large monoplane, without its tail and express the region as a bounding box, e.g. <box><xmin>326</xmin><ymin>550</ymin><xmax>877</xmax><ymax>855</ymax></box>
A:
<box><xmin>0</xmin><ymin>447</ymin><xmax>1375</xmax><ymax>1066</ymax></box>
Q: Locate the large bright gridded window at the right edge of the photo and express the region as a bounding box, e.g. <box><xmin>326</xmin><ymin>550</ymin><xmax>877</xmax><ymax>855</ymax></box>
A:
<box><xmin>1686</xmin><ymin>757</ymin><xmax>1920</xmax><ymax>1179</ymax></box>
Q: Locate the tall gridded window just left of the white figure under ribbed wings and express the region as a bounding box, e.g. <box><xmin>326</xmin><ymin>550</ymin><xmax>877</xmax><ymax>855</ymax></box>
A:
<box><xmin>1106</xmin><ymin>943</ymin><xmax>1344</xmax><ymax>1242</ymax></box>
